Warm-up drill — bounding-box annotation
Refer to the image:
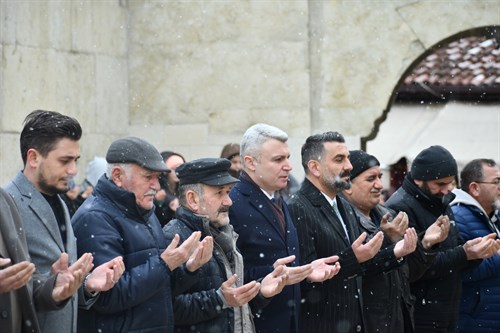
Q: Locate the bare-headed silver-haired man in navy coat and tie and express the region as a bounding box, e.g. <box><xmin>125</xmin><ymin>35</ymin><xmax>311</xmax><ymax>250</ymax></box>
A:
<box><xmin>229</xmin><ymin>124</ymin><xmax>339</xmax><ymax>333</ymax></box>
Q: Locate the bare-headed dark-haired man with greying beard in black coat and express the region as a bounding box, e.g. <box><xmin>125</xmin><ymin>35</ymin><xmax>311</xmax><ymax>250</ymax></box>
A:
<box><xmin>289</xmin><ymin>132</ymin><xmax>416</xmax><ymax>333</ymax></box>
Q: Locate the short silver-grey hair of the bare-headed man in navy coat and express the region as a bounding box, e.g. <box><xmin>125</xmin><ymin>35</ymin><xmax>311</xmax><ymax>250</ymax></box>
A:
<box><xmin>240</xmin><ymin>124</ymin><xmax>288</xmax><ymax>167</ymax></box>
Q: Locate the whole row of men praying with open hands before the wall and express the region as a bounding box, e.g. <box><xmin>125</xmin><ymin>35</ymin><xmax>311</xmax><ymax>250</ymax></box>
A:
<box><xmin>0</xmin><ymin>110</ymin><xmax>500</xmax><ymax>333</ymax></box>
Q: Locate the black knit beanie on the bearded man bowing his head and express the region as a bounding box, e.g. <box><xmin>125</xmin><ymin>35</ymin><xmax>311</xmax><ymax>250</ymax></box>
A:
<box><xmin>411</xmin><ymin>146</ymin><xmax>458</xmax><ymax>180</ymax></box>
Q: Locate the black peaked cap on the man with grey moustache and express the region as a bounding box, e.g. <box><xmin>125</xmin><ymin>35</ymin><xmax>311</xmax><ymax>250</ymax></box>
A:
<box><xmin>175</xmin><ymin>158</ymin><xmax>239</xmax><ymax>186</ymax></box>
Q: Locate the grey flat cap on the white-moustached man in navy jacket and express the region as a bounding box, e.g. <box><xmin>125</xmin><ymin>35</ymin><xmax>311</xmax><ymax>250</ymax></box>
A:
<box><xmin>106</xmin><ymin>136</ymin><xmax>170</xmax><ymax>172</ymax></box>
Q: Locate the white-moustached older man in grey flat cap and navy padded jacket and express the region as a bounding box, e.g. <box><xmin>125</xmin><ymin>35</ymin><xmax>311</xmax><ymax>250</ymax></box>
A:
<box><xmin>72</xmin><ymin>137</ymin><xmax>211</xmax><ymax>333</ymax></box>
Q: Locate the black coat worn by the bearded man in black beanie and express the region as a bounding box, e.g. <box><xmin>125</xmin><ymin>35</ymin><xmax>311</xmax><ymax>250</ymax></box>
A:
<box><xmin>386</xmin><ymin>174</ymin><xmax>480</xmax><ymax>332</ymax></box>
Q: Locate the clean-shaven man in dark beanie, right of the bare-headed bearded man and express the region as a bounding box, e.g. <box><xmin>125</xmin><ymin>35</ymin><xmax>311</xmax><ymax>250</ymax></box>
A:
<box><xmin>343</xmin><ymin>150</ymin><xmax>450</xmax><ymax>333</ymax></box>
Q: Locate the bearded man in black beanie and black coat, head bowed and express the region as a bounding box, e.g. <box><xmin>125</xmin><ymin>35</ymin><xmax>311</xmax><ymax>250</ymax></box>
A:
<box><xmin>386</xmin><ymin>146</ymin><xmax>499</xmax><ymax>333</ymax></box>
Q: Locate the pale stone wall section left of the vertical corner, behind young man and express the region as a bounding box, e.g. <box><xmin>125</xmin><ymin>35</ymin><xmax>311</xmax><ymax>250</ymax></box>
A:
<box><xmin>0</xmin><ymin>0</ymin><xmax>129</xmax><ymax>184</ymax></box>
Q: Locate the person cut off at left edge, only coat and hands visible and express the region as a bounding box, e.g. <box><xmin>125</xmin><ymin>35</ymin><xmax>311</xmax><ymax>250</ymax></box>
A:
<box><xmin>0</xmin><ymin>188</ymin><xmax>97</xmax><ymax>333</ymax></box>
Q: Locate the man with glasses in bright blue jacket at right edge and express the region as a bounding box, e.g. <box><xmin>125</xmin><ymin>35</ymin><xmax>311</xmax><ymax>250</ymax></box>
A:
<box><xmin>451</xmin><ymin>159</ymin><xmax>500</xmax><ymax>333</ymax></box>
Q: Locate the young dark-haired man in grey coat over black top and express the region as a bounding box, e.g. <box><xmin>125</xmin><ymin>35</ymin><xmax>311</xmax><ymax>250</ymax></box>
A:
<box><xmin>5</xmin><ymin>110</ymin><xmax>124</xmax><ymax>333</ymax></box>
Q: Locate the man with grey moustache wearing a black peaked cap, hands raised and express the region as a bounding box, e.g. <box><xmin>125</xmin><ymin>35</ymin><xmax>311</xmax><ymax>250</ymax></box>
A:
<box><xmin>163</xmin><ymin>158</ymin><xmax>293</xmax><ymax>333</ymax></box>
